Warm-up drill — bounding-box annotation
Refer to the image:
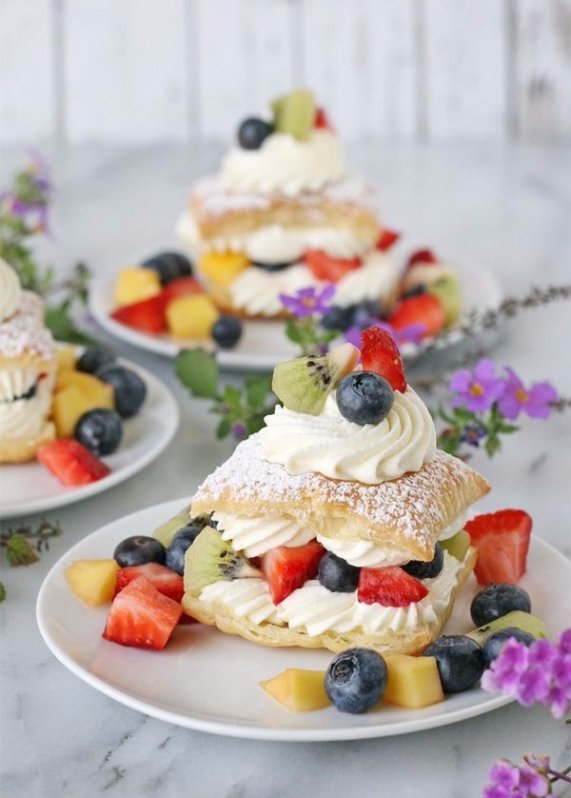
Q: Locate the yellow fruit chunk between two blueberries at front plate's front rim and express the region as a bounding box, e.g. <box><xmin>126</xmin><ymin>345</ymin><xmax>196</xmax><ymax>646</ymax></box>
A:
<box><xmin>383</xmin><ymin>654</ymin><xmax>444</xmax><ymax>709</ymax></box>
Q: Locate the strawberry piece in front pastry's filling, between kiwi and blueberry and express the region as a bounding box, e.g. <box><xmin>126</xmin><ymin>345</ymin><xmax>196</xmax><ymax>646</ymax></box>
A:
<box><xmin>262</xmin><ymin>540</ymin><xmax>325</xmax><ymax>604</ymax></box>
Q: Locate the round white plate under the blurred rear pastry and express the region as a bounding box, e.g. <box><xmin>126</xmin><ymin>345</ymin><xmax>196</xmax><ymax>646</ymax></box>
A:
<box><xmin>89</xmin><ymin>267</ymin><xmax>502</xmax><ymax>371</ymax></box>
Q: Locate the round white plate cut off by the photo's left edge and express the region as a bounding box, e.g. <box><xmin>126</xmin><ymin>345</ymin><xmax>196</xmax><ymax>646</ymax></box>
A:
<box><xmin>0</xmin><ymin>359</ymin><xmax>179</xmax><ymax>518</ymax></box>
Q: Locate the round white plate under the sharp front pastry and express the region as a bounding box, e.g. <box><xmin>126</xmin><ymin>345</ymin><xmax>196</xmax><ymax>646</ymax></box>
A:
<box><xmin>36</xmin><ymin>499</ymin><xmax>571</xmax><ymax>741</ymax></box>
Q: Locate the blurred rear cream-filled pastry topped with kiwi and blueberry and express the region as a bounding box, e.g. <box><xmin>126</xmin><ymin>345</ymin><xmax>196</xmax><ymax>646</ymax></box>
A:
<box><xmin>177</xmin><ymin>91</ymin><xmax>400</xmax><ymax>318</ymax></box>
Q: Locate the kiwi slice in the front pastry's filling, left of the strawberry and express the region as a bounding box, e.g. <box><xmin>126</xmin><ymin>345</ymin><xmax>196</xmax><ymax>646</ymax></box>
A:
<box><xmin>184</xmin><ymin>526</ymin><xmax>260</xmax><ymax>596</ymax></box>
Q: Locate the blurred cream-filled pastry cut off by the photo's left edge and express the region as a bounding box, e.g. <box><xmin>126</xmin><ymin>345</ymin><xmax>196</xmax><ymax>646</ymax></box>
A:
<box><xmin>0</xmin><ymin>258</ymin><xmax>57</xmax><ymax>463</ymax></box>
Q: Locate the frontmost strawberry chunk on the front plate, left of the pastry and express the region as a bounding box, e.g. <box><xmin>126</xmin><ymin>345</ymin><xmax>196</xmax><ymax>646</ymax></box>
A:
<box><xmin>103</xmin><ymin>576</ymin><xmax>182</xmax><ymax>651</ymax></box>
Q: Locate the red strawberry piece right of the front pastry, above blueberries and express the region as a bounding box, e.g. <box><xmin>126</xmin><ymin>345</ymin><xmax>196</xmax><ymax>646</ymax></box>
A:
<box><xmin>464</xmin><ymin>510</ymin><xmax>532</xmax><ymax>585</ymax></box>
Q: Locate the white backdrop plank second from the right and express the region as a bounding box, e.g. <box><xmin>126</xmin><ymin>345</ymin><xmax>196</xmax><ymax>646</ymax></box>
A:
<box><xmin>424</xmin><ymin>0</ymin><xmax>507</xmax><ymax>140</ymax></box>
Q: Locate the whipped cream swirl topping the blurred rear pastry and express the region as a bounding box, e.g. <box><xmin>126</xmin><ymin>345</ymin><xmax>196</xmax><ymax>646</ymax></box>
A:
<box><xmin>222</xmin><ymin>130</ymin><xmax>345</xmax><ymax>196</ymax></box>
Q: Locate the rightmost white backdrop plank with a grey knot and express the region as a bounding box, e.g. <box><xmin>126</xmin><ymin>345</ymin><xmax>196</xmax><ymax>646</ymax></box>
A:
<box><xmin>514</xmin><ymin>0</ymin><xmax>571</xmax><ymax>141</ymax></box>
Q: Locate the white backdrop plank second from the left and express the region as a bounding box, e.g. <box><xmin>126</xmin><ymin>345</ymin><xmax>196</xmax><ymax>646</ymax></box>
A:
<box><xmin>65</xmin><ymin>0</ymin><xmax>187</xmax><ymax>142</ymax></box>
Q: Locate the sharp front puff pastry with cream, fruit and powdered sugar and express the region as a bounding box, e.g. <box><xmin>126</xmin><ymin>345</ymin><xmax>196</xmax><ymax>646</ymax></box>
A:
<box><xmin>183</xmin><ymin>328</ymin><xmax>489</xmax><ymax>654</ymax></box>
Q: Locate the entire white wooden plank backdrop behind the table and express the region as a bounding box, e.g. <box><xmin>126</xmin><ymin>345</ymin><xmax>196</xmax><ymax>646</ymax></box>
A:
<box><xmin>0</xmin><ymin>0</ymin><xmax>571</xmax><ymax>145</ymax></box>
